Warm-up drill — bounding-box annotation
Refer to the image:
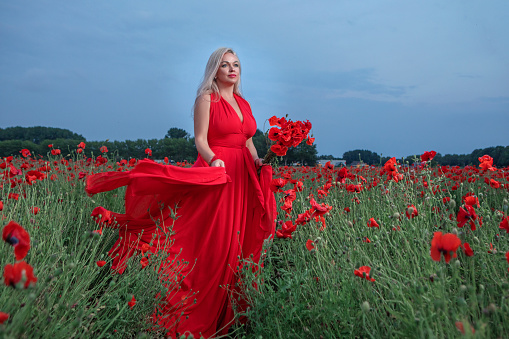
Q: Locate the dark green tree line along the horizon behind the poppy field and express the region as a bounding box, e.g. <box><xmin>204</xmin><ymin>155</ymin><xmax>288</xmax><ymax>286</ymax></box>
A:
<box><xmin>0</xmin><ymin>126</ymin><xmax>509</xmax><ymax>167</ymax></box>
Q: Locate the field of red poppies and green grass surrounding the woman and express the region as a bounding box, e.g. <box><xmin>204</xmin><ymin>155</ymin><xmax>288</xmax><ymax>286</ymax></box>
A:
<box><xmin>0</xmin><ymin>147</ymin><xmax>509</xmax><ymax>338</ymax></box>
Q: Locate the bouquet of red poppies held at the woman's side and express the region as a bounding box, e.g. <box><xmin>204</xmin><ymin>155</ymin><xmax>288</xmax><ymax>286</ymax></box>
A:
<box><xmin>263</xmin><ymin>116</ymin><xmax>315</xmax><ymax>164</ymax></box>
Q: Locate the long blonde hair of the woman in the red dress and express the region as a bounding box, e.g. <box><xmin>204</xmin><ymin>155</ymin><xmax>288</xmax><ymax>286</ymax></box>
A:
<box><xmin>194</xmin><ymin>47</ymin><xmax>242</xmax><ymax>106</ymax></box>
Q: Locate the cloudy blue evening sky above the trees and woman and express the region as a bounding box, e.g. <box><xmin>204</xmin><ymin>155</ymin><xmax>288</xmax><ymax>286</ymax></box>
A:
<box><xmin>0</xmin><ymin>0</ymin><xmax>509</xmax><ymax>157</ymax></box>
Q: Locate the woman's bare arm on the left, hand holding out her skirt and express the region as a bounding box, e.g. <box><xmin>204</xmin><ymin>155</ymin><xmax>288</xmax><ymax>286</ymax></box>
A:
<box><xmin>194</xmin><ymin>95</ymin><xmax>224</xmax><ymax>167</ymax></box>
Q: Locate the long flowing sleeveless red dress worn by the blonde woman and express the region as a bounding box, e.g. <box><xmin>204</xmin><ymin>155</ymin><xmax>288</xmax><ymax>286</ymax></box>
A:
<box><xmin>86</xmin><ymin>95</ymin><xmax>276</xmax><ymax>337</ymax></box>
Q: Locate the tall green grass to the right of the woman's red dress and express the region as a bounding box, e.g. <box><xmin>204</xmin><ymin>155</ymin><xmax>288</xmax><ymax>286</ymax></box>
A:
<box><xmin>237</xmin><ymin>163</ymin><xmax>509</xmax><ymax>338</ymax></box>
